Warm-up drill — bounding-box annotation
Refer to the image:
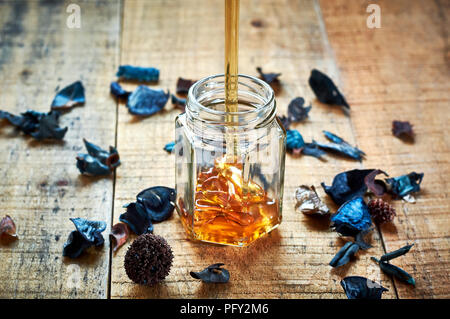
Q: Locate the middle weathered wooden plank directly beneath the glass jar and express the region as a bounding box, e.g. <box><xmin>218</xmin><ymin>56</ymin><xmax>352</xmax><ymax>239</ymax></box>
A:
<box><xmin>111</xmin><ymin>0</ymin><xmax>395</xmax><ymax>298</ymax></box>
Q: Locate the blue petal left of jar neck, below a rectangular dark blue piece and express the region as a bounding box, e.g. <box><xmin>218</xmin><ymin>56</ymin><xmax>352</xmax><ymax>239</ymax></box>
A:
<box><xmin>127</xmin><ymin>85</ymin><xmax>170</xmax><ymax>116</ymax></box>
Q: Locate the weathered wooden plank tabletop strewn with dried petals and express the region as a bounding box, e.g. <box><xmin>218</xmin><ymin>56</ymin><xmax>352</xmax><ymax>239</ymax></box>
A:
<box><xmin>0</xmin><ymin>0</ymin><xmax>450</xmax><ymax>298</ymax></box>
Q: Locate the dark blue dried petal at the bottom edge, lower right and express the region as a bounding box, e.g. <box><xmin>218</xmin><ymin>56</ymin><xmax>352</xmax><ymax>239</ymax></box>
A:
<box><xmin>341</xmin><ymin>276</ymin><xmax>388</xmax><ymax>299</ymax></box>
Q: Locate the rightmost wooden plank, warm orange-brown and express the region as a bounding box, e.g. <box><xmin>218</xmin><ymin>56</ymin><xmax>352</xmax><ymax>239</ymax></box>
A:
<box><xmin>320</xmin><ymin>0</ymin><xmax>450</xmax><ymax>298</ymax></box>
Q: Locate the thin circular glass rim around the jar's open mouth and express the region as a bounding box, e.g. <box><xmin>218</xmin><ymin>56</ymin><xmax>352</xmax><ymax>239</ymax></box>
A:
<box><xmin>186</xmin><ymin>73</ymin><xmax>275</xmax><ymax>116</ymax></box>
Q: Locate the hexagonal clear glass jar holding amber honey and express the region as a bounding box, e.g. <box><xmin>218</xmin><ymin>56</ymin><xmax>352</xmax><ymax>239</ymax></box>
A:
<box><xmin>174</xmin><ymin>74</ymin><xmax>286</xmax><ymax>246</ymax></box>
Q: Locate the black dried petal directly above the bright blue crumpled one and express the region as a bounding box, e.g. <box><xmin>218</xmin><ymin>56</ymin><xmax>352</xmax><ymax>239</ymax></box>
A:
<box><xmin>321</xmin><ymin>169</ymin><xmax>374</xmax><ymax>205</ymax></box>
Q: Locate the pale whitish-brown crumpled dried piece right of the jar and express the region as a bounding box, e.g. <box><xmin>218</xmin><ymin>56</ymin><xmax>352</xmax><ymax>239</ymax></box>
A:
<box><xmin>295</xmin><ymin>185</ymin><xmax>330</xmax><ymax>216</ymax></box>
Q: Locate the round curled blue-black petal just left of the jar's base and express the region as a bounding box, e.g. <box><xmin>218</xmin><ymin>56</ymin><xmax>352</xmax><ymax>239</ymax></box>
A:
<box><xmin>136</xmin><ymin>186</ymin><xmax>176</xmax><ymax>222</ymax></box>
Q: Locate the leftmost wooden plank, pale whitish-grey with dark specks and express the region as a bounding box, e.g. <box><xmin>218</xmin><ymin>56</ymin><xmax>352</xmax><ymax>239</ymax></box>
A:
<box><xmin>0</xmin><ymin>0</ymin><xmax>120</xmax><ymax>298</ymax></box>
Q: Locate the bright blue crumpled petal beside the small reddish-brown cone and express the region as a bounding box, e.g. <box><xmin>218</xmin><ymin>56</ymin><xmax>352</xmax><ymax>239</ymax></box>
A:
<box><xmin>331</xmin><ymin>197</ymin><xmax>372</xmax><ymax>236</ymax></box>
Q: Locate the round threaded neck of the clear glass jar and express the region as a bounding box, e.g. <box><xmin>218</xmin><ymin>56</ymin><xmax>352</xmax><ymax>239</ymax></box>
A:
<box><xmin>186</xmin><ymin>74</ymin><xmax>276</xmax><ymax>130</ymax></box>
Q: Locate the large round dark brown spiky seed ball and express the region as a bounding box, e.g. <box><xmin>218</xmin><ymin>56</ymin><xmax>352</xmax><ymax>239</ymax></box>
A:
<box><xmin>124</xmin><ymin>234</ymin><xmax>173</xmax><ymax>286</ymax></box>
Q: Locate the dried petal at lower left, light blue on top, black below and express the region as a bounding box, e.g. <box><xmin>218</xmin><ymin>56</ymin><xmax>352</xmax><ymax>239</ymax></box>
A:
<box><xmin>63</xmin><ymin>218</ymin><xmax>106</xmax><ymax>258</ymax></box>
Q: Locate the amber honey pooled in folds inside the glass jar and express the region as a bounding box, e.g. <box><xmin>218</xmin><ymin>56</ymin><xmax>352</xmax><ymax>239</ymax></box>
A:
<box><xmin>179</xmin><ymin>156</ymin><xmax>280</xmax><ymax>246</ymax></box>
